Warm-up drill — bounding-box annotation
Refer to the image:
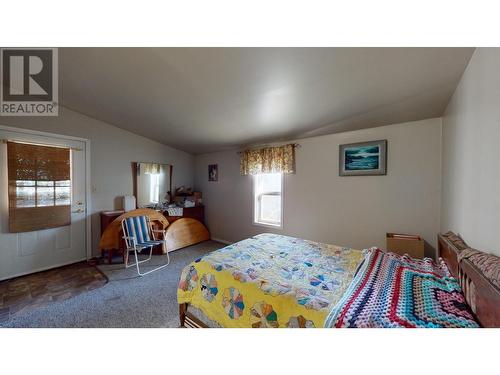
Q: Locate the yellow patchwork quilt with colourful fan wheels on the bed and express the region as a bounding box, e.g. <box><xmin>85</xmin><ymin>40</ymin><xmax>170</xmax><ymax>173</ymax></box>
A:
<box><xmin>177</xmin><ymin>233</ymin><xmax>363</xmax><ymax>328</ymax></box>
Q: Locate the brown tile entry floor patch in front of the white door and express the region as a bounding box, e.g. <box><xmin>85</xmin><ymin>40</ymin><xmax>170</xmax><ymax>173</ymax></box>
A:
<box><xmin>0</xmin><ymin>262</ymin><xmax>108</xmax><ymax>323</ymax></box>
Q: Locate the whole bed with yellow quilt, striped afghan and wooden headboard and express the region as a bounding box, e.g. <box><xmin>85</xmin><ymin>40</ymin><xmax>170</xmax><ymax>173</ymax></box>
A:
<box><xmin>177</xmin><ymin>234</ymin><xmax>500</xmax><ymax>328</ymax></box>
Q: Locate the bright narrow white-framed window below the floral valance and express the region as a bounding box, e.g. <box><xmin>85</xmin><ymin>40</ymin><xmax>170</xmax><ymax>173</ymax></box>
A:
<box><xmin>253</xmin><ymin>173</ymin><xmax>283</xmax><ymax>228</ymax></box>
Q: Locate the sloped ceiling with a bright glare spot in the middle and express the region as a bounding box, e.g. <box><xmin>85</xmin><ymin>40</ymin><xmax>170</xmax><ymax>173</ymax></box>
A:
<box><xmin>59</xmin><ymin>48</ymin><xmax>474</xmax><ymax>154</ymax></box>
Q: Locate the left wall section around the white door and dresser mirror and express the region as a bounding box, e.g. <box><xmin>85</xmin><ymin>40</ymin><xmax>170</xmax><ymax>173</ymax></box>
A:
<box><xmin>0</xmin><ymin>107</ymin><xmax>194</xmax><ymax>253</ymax></box>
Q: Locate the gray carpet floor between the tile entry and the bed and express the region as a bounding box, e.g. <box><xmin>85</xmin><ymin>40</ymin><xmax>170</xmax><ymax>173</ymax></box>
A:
<box><xmin>2</xmin><ymin>241</ymin><xmax>226</xmax><ymax>328</ymax></box>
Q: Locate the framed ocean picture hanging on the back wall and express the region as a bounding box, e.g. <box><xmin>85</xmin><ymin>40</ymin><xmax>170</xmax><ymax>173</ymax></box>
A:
<box><xmin>339</xmin><ymin>139</ymin><xmax>387</xmax><ymax>176</ymax></box>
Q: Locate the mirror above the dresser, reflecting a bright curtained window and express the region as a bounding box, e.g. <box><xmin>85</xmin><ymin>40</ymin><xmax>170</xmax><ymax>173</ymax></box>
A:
<box><xmin>132</xmin><ymin>162</ymin><xmax>172</xmax><ymax>208</ymax></box>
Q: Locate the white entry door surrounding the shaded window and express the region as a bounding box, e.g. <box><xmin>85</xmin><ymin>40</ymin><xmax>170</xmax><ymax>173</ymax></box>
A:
<box><xmin>0</xmin><ymin>126</ymin><xmax>88</xmax><ymax>280</ymax></box>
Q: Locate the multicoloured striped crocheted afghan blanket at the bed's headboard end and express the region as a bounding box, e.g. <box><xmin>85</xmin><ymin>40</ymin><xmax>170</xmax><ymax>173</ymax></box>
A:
<box><xmin>325</xmin><ymin>248</ymin><xmax>479</xmax><ymax>328</ymax></box>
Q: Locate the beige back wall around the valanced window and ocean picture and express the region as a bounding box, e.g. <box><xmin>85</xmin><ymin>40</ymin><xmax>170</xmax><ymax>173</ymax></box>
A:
<box><xmin>195</xmin><ymin>119</ymin><xmax>441</xmax><ymax>256</ymax></box>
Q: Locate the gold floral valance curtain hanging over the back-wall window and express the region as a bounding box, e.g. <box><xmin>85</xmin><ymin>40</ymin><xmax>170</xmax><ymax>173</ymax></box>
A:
<box><xmin>240</xmin><ymin>144</ymin><xmax>295</xmax><ymax>175</ymax></box>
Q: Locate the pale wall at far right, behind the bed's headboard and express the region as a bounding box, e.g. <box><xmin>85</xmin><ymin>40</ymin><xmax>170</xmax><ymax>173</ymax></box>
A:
<box><xmin>441</xmin><ymin>48</ymin><xmax>500</xmax><ymax>255</ymax></box>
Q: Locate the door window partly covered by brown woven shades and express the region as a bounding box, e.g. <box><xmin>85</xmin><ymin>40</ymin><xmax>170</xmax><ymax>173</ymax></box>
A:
<box><xmin>7</xmin><ymin>142</ymin><xmax>71</xmax><ymax>233</ymax></box>
